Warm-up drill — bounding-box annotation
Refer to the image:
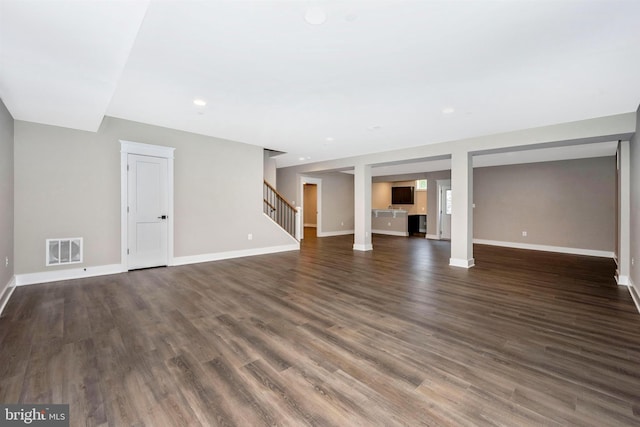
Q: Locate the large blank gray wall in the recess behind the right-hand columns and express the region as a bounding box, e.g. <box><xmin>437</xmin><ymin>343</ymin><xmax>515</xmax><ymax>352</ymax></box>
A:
<box><xmin>473</xmin><ymin>157</ymin><xmax>616</xmax><ymax>252</ymax></box>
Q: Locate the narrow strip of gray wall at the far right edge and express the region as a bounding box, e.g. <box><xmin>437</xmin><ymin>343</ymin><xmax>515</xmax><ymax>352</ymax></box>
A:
<box><xmin>629</xmin><ymin>108</ymin><xmax>640</xmax><ymax>294</ymax></box>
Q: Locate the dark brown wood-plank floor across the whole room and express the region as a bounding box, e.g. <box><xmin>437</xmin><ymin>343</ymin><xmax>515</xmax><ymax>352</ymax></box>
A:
<box><xmin>0</xmin><ymin>235</ymin><xmax>640</xmax><ymax>427</ymax></box>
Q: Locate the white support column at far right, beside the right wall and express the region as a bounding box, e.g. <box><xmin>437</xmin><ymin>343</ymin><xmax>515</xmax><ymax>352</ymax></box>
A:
<box><xmin>616</xmin><ymin>141</ymin><xmax>631</xmax><ymax>286</ymax></box>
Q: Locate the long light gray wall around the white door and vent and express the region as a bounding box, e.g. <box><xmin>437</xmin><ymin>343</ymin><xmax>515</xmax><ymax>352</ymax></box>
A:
<box><xmin>14</xmin><ymin>117</ymin><xmax>292</xmax><ymax>274</ymax></box>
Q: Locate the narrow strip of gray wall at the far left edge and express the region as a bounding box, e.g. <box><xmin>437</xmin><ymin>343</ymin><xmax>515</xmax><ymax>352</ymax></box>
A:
<box><xmin>0</xmin><ymin>100</ymin><xmax>14</xmax><ymax>295</ymax></box>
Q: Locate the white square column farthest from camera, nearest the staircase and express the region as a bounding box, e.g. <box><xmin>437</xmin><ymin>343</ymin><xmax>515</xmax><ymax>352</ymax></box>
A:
<box><xmin>353</xmin><ymin>165</ymin><xmax>373</xmax><ymax>251</ymax></box>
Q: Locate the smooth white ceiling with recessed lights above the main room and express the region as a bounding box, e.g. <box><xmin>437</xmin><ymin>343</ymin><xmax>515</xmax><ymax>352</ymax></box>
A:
<box><xmin>0</xmin><ymin>0</ymin><xmax>640</xmax><ymax>167</ymax></box>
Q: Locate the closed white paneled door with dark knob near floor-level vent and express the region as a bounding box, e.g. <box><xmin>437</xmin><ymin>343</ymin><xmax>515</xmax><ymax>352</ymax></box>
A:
<box><xmin>127</xmin><ymin>154</ymin><xmax>169</xmax><ymax>269</ymax></box>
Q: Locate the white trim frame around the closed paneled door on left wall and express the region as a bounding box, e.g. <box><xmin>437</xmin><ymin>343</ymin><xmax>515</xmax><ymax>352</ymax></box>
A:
<box><xmin>120</xmin><ymin>139</ymin><xmax>175</xmax><ymax>271</ymax></box>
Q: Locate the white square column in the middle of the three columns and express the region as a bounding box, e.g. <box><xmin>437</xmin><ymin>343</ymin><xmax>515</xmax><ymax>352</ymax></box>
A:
<box><xmin>449</xmin><ymin>151</ymin><xmax>474</xmax><ymax>268</ymax></box>
